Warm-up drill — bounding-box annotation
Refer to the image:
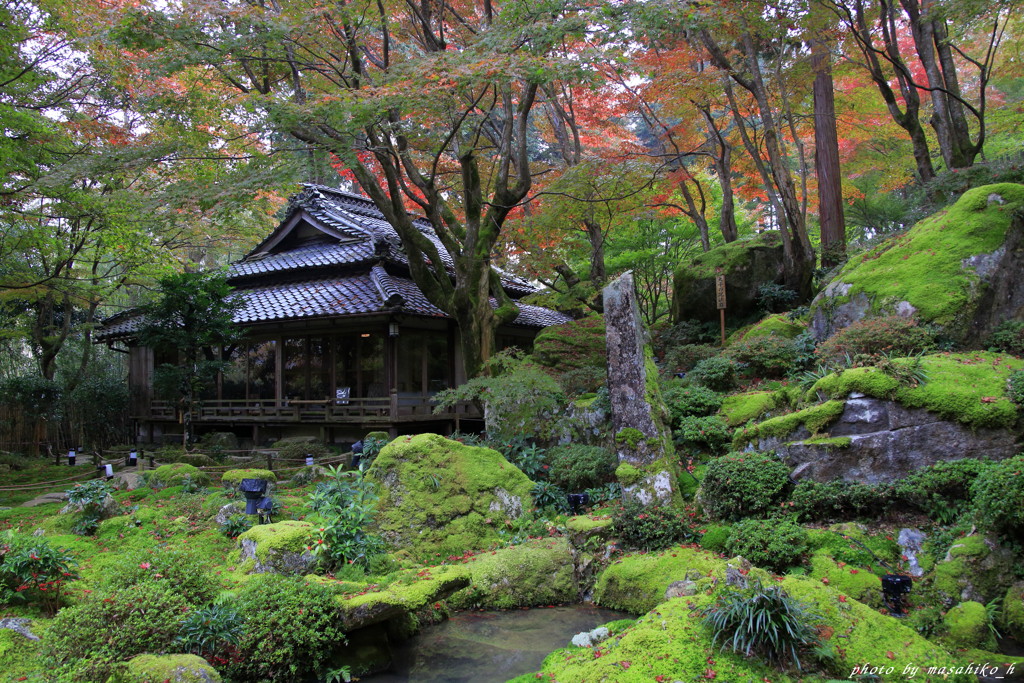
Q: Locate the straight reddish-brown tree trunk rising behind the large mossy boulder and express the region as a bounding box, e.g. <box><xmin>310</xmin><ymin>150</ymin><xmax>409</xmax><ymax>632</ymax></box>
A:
<box><xmin>811</xmin><ymin>36</ymin><xmax>846</xmax><ymax>267</ymax></box>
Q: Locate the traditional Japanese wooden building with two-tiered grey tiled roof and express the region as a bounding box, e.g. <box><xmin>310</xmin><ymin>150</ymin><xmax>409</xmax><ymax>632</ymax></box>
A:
<box><xmin>97</xmin><ymin>185</ymin><xmax>569</xmax><ymax>445</ymax></box>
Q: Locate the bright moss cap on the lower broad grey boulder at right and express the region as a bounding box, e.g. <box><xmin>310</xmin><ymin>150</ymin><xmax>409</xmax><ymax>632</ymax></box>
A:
<box><xmin>808</xmin><ymin>351</ymin><xmax>1024</xmax><ymax>428</ymax></box>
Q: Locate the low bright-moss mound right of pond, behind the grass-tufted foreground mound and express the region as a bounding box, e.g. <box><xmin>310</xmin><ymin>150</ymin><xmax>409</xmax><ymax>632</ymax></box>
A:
<box><xmin>594</xmin><ymin>547</ymin><xmax>768</xmax><ymax>614</ymax></box>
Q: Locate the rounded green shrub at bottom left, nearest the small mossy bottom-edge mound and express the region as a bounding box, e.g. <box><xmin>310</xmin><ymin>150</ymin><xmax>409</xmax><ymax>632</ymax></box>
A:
<box><xmin>43</xmin><ymin>582</ymin><xmax>186</xmax><ymax>683</ymax></box>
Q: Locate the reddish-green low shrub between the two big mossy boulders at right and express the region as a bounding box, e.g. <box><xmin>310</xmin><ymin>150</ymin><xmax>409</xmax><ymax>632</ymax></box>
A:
<box><xmin>815</xmin><ymin>315</ymin><xmax>934</xmax><ymax>364</ymax></box>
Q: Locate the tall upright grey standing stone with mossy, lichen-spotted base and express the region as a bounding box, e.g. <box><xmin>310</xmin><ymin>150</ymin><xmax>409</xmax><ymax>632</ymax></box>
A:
<box><xmin>604</xmin><ymin>272</ymin><xmax>676</xmax><ymax>505</ymax></box>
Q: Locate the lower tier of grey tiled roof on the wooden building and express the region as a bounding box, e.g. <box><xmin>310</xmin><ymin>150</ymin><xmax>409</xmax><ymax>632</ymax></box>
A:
<box><xmin>96</xmin><ymin>274</ymin><xmax>570</xmax><ymax>341</ymax></box>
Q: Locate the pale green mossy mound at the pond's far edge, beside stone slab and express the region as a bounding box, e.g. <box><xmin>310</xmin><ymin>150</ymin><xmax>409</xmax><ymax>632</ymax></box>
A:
<box><xmin>449</xmin><ymin>539</ymin><xmax>580</xmax><ymax>609</ymax></box>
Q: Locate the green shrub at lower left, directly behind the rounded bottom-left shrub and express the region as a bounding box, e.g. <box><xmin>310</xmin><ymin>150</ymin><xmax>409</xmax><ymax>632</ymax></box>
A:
<box><xmin>103</xmin><ymin>548</ymin><xmax>219</xmax><ymax>605</ymax></box>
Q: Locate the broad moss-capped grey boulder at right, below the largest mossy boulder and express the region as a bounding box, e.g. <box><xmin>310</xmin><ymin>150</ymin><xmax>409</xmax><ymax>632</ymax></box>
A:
<box><xmin>734</xmin><ymin>353</ymin><xmax>1024</xmax><ymax>483</ymax></box>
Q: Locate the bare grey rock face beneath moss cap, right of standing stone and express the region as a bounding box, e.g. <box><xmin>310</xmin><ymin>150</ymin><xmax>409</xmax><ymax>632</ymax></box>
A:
<box><xmin>757</xmin><ymin>393</ymin><xmax>1019</xmax><ymax>483</ymax></box>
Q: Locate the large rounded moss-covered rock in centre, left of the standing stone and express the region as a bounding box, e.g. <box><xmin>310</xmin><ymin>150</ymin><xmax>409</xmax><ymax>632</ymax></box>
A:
<box><xmin>368</xmin><ymin>434</ymin><xmax>534</xmax><ymax>559</ymax></box>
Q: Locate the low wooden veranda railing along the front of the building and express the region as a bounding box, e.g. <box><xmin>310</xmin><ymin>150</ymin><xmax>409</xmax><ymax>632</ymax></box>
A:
<box><xmin>147</xmin><ymin>393</ymin><xmax>479</xmax><ymax>423</ymax></box>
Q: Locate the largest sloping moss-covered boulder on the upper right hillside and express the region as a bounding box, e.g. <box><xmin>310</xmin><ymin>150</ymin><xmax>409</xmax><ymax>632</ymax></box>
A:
<box><xmin>811</xmin><ymin>183</ymin><xmax>1024</xmax><ymax>343</ymax></box>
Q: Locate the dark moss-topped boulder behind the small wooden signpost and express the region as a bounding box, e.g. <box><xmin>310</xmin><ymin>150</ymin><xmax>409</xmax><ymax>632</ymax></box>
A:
<box><xmin>672</xmin><ymin>231</ymin><xmax>784</xmax><ymax>323</ymax></box>
